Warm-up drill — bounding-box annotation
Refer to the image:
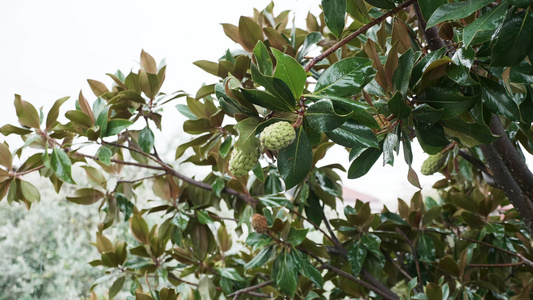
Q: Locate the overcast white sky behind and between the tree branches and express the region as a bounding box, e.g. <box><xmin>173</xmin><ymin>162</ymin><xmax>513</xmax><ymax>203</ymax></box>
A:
<box><xmin>0</xmin><ymin>0</ymin><xmax>528</xmax><ymax>207</ymax></box>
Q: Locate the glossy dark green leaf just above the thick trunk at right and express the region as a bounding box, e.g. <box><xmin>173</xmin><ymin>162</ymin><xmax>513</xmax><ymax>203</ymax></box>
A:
<box><xmin>479</xmin><ymin>77</ymin><xmax>520</xmax><ymax>121</ymax></box>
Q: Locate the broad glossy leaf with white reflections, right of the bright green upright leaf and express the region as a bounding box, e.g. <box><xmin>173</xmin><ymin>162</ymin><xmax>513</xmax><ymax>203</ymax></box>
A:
<box><xmin>314</xmin><ymin>57</ymin><xmax>376</xmax><ymax>97</ymax></box>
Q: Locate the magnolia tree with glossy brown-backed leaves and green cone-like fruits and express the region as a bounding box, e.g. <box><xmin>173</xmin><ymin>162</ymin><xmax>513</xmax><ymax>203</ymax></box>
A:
<box><xmin>0</xmin><ymin>0</ymin><xmax>533</xmax><ymax>299</ymax></box>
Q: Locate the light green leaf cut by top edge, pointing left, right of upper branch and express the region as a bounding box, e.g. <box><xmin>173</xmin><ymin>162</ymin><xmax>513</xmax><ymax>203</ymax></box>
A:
<box><xmin>427</xmin><ymin>0</ymin><xmax>492</xmax><ymax>29</ymax></box>
